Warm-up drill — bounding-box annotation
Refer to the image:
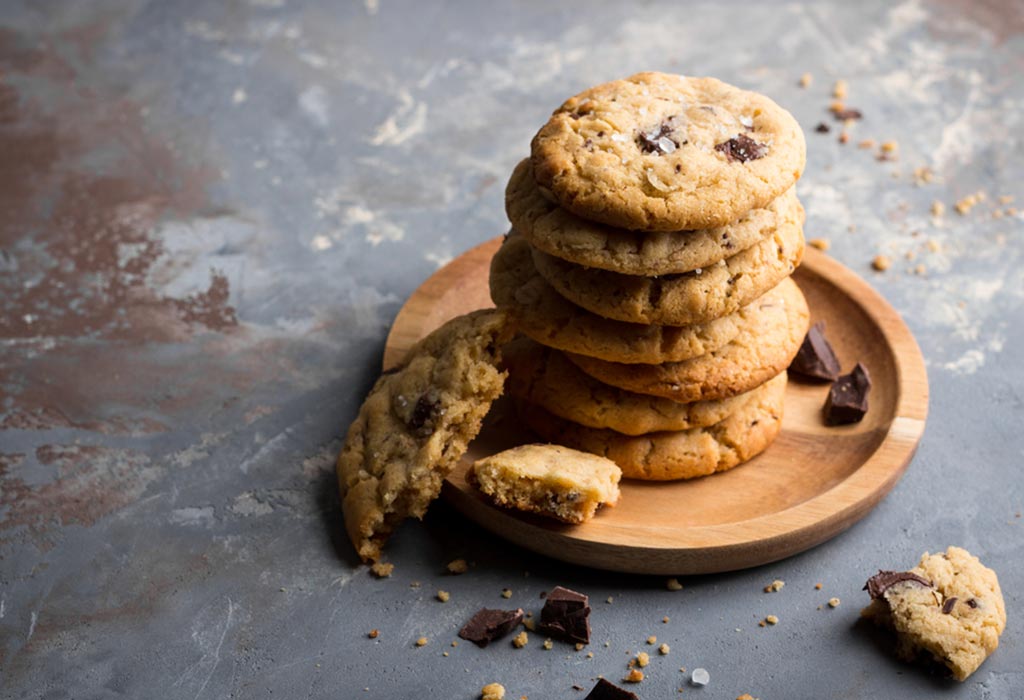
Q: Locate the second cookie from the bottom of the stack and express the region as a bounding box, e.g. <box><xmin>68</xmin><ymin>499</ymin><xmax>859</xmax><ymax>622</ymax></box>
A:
<box><xmin>502</xmin><ymin>338</ymin><xmax>743</xmax><ymax>435</ymax></box>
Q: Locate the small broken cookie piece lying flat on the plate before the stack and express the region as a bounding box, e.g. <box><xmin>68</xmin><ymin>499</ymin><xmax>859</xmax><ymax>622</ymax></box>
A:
<box><xmin>467</xmin><ymin>445</ymin><xmax>623</xmax><ymax>524</ymax></box>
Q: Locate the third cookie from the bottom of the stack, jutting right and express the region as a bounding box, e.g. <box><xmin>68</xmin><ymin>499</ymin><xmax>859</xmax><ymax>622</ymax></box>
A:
<box><xmin>565</xmin><ymin>279</ymin><xmax>810</xmax><ymax>403</ymax></box>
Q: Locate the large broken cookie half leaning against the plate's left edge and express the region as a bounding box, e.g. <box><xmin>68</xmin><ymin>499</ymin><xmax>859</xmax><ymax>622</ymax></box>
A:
<box><xmin>337</xmin><ymin>309</ymin><xmax>512</xmax><ymax>561</ymax></box>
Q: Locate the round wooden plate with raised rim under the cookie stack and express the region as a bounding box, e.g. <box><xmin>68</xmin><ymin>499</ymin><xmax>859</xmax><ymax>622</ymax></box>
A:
<box><xmin>384</xmin><ymin>238</ymin><xmax>928</xmax><ymax>574</ymax></box>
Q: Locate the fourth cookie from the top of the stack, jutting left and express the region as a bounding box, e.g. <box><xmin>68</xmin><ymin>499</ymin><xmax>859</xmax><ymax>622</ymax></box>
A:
<box><xmin>490</xmin><ymin>231</ymin><xmax>741</xmax><ymax>363</ymax></box>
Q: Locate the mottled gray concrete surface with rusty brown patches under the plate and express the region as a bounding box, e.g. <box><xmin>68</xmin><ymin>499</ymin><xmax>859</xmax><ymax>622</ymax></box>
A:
<box><xmin>0</xmin><ymin>0</ymin><xmax>1024</xmax><ymax>700</ymax></box>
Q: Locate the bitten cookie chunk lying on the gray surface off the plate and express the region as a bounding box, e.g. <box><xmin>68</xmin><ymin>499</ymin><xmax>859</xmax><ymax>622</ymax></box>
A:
<box><xmin>860</xmin><ymin>546</ymin><xmax>1007</xmax><ymax>681</ymax></box>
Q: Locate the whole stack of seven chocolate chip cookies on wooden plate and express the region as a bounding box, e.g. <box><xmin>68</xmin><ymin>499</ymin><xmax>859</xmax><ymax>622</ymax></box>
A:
<box><xmin>490</xmin><ymin>73</ymin><xmax>808</xmax><ymax>480</ymax></box>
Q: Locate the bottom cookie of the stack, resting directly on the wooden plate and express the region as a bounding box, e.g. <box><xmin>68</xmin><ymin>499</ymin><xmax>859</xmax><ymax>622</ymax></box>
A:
<box><xmin>519</xmin><ymin>373</ymin><xmax>785</xmax><ymax>481</ymax></box>
